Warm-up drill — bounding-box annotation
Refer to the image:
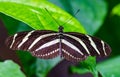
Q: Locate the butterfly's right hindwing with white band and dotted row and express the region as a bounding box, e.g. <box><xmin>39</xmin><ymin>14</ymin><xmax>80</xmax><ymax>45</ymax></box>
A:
<box><xmin>61</xmin><ymin>35</ymin><xmax>87</xmax><ymax>62</ymax></box>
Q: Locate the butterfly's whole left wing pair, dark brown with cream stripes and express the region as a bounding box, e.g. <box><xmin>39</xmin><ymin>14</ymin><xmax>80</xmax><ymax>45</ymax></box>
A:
<box><xmin>6</xmin><ymin>30</ymin><xmax>59</xmax><ymax>59</ymax></box>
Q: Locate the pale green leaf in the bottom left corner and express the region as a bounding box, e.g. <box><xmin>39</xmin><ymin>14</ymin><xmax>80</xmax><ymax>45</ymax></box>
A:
<box><xmin>0</xmin><ymin>60</ymin><xmax>25</xmax><ymax>77</ymax></box>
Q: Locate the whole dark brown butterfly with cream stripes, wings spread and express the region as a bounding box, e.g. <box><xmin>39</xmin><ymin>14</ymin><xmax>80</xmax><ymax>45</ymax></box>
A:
<box><xmin>6</xmin><ymin>26</ymin><xmax>111</xmax><ymax>61</ymax></box>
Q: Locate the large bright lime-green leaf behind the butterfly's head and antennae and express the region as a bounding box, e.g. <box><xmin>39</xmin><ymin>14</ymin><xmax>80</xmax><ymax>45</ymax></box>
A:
<box><xmin>0</xmin><ymin>0</ymin><xmax>85</xmax><ymax>33</ymax></box>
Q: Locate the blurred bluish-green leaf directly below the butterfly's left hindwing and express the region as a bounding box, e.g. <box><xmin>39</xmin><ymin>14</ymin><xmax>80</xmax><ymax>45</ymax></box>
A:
<box><xmin>36</xmin><ymin>57</ymin><xmax>61</xmax><ymax>77</ymax></box>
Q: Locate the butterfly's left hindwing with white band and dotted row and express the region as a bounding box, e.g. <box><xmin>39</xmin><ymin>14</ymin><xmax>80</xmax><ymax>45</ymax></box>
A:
<box><xmin>32</xmin><ymin>35</ymin><xmax>59</xmax><ymax>59</ymax></box>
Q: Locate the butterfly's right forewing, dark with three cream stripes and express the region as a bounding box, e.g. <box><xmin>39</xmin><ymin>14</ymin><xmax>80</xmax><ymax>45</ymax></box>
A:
<box><xmin>63</xmin><ymin>32</ymin><xmax>111</xmax><ymax>57</ymax></box>
